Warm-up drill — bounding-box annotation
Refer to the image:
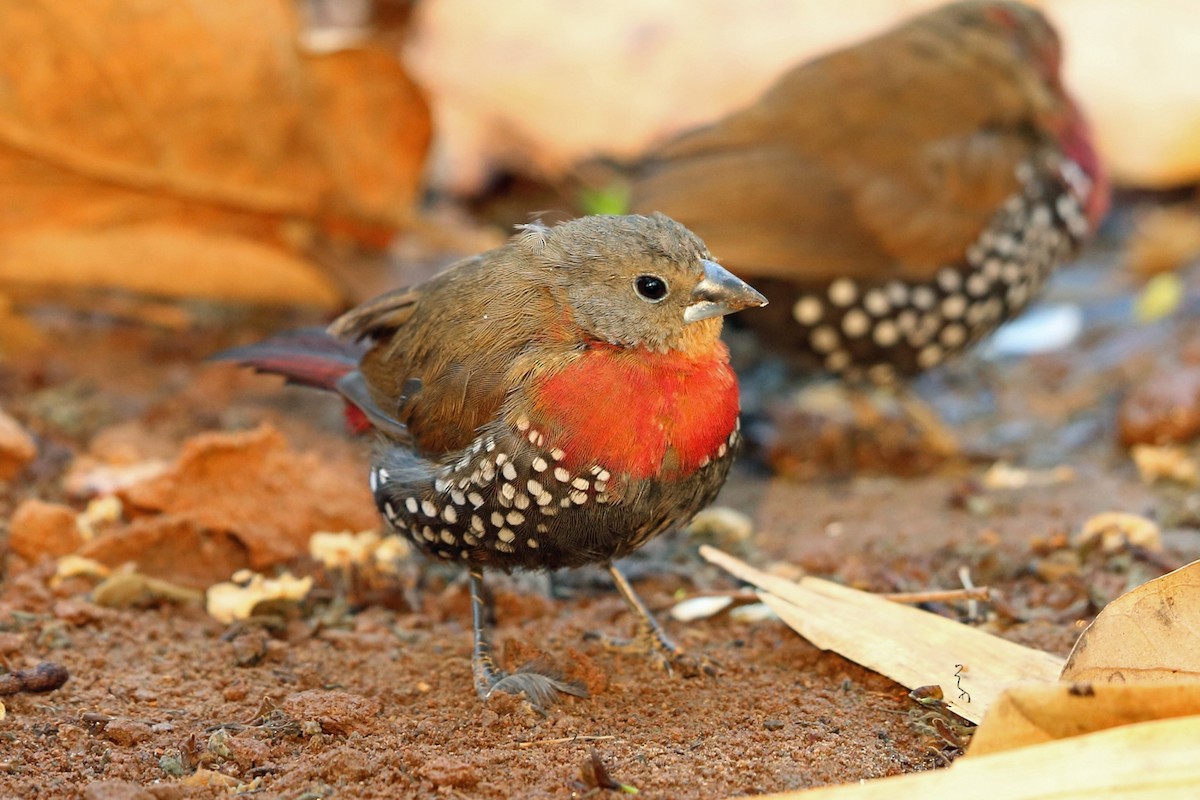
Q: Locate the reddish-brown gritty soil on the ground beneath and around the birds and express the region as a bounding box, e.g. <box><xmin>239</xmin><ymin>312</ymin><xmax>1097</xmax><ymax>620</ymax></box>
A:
<box><xmin>0</xmin><ymin>230</ymin><xmax>1200</xmax><ymax>799</ymax></box>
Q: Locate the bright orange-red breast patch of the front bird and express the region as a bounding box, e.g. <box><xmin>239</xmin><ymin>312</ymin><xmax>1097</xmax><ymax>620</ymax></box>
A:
<box><xmin>533</xmin><ymin>342</ymin><xmax>738</xmax><ymax>480</ymax></box>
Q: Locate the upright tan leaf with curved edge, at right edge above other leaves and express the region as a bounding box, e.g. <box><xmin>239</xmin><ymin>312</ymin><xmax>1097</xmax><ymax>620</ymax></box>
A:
<box><xmin>1062</xmin><ymin>561</ymin><xmax>1200</xmax><ymax>682</ymax></box>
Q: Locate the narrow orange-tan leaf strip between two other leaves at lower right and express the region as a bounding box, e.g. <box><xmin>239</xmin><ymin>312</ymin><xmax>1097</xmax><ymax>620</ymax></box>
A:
<box><xmin>967</xmin><ymin>681</ymin><xmax>1200</xmax><ymax>757</ymax></box>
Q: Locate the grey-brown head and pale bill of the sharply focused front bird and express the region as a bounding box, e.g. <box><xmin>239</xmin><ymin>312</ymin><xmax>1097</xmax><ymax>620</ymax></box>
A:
<box><xmin>516</xmin><ymin>213</ymin><xmax>767</xmax><ymax>353</ymax></box>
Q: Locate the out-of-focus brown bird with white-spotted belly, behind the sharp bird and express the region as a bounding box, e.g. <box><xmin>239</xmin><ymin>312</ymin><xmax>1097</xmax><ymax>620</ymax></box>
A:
<box><xmin>632</xmin><ymin>1</ymin><xmax>1109</xmax><ymax>384</ymax></box>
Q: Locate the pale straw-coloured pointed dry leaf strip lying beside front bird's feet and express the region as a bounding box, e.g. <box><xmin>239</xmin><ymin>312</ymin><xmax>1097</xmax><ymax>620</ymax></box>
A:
<box><xmin>700</xmin><ymin>546</ymin><xmax>1062</xmax><ymax>722</ymax></box>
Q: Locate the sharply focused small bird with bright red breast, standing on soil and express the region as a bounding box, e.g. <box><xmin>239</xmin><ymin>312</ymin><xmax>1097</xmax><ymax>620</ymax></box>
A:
<box><xmin>218</xmin><ymin>215</ymin><xmax>767</xmax><ymax>706</ymax></box>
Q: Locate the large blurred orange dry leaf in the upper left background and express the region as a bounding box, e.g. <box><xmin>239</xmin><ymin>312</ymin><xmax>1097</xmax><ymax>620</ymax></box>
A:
<box><xmin>0</xmin><ymin>0</ymin><xmax>430</xmax><ymax>306</ymax></box>
